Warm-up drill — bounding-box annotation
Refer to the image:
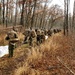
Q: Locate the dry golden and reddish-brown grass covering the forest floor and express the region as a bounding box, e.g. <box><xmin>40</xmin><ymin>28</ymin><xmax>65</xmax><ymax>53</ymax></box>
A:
<box><xmin>0</xmin><ymin>29</ymin><xmax>75</xmax><ymax>75</ymax></box>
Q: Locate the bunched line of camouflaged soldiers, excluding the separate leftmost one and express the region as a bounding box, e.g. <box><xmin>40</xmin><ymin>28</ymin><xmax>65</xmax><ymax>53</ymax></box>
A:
<box><xmin>23</xmin><ymin>29</ymin><xmax>61</xmax><ymax>46</ymax></box>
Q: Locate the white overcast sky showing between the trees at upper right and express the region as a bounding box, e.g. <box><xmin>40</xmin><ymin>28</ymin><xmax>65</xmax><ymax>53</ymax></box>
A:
<box><xmin>50</xmin><ymin>0</ymin><xmax>74</xmax><ymax>13</ymax></box>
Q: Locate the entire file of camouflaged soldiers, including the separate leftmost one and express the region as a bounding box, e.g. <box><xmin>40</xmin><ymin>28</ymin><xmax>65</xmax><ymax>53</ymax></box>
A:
<box><xmin>5</xmin><ymin>27</ymin><xmax>61</xmax><ymax>57</ymax></box>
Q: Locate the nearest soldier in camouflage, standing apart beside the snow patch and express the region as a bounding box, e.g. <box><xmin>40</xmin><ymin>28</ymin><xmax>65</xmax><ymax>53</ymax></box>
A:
<box><xmin>5</xmin><ymin>30</ymin><xmax>19</xmax><ymax>57</ymax></box>
